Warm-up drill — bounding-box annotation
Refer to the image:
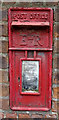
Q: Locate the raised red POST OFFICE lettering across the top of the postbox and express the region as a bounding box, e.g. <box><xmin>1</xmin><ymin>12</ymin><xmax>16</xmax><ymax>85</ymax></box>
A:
<box><xmin>12</xmin><ymin>13</ymin><xmax>48</xmax><ymax>20</ymax></box>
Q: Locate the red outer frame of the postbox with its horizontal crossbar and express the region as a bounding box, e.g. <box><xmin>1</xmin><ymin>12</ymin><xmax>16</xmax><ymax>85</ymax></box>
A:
<box><xmin>8</xmin><ymin>7</ymin><xmax>53</xmax><ymax>111</ymax></box>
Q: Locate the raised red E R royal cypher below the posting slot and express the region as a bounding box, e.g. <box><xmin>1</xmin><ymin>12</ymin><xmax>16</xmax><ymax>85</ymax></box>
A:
<box><xmin>20</xmin><ymin>34</ymin><xmax>43</xmax><ymax>46</ymax></box>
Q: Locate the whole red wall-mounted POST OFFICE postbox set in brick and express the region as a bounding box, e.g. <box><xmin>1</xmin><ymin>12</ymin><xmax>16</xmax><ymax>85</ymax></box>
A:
<box><xmin>9</xmin><ymin>8</ymin><xmax>53</xmax><ymax>111</ymax></box>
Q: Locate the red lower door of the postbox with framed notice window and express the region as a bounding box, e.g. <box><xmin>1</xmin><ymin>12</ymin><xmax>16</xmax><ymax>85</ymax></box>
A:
<box><xmin>10</xmin><ymin>51</ymin><xmax>52</xmax><ymax>110</ymax></box>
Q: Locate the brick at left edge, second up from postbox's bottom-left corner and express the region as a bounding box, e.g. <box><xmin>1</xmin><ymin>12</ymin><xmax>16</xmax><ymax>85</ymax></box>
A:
<box><xmin>0</xmin><ymin>84</ymin><xmax>9</xmax><ymax>97</ymax></box>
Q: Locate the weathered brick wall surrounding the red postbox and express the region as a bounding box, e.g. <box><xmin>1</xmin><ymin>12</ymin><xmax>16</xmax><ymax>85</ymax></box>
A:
<box><xmin>0</xmin><ymin>2</ymin><xmax>59</xmax><ymax>118</ymax></box>
